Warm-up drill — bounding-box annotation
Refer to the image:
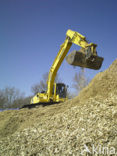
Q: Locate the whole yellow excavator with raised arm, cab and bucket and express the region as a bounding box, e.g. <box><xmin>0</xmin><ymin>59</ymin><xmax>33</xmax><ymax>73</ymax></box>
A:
<box><xmin>22</xmin><ymin>30</ymin><xmax>103</xmax><ymax>106</ymax></box>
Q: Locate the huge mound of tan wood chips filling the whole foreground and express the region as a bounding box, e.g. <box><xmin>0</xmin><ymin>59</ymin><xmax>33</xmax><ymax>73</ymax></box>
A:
<box><xmin>0</xmin><ymin>60</ymin><xmax>117</xmax><ymax>156</ymax></box>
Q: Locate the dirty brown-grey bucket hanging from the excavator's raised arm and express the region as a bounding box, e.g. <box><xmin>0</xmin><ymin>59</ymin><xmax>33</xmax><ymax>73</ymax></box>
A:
<box><xmin>66</xmin><ymin>50</ymin><xmax>104</xmax><ymax>70</ymax></box>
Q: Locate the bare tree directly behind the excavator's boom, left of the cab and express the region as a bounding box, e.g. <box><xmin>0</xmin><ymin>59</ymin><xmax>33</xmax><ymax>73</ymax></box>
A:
<box><xmin>31</xmin><ymin>73</ymin><xmax>62</xmax><ymax>95</ymax></box>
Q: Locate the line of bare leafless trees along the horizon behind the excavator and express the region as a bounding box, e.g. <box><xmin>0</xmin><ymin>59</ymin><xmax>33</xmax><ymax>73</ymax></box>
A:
<box><xmin>0</xmin><ymin>68</ymin><xmax>88</xmax><ymax>109</ymax></box>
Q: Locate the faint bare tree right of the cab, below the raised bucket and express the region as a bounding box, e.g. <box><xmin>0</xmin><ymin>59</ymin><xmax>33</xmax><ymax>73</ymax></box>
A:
<box><xmin>72</xmin><ymin>68</ymin><xmax>89</xmax><ymax>93</ymax></box>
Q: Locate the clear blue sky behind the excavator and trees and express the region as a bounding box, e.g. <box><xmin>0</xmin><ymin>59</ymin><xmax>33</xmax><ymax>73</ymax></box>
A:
<box><xmin>0</xmin><ymin>0</ymin><xmax>117</xmax><ymax>96</ymax></box>
